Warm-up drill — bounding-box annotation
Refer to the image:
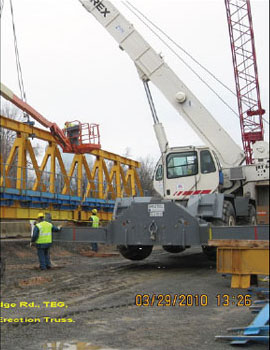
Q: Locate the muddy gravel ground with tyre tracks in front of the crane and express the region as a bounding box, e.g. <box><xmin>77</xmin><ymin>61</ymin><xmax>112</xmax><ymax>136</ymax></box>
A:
<box><xmin>1</xmin><ymin>240</ymin><xmax>267</xmax><ymax>350</ymax></box>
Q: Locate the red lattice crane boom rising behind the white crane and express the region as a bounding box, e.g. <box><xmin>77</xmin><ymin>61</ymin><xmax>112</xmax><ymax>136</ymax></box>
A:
<box><xmin>225</xmin><ymin>0</ymin><xmax>265</xmax><ymax>164</ymax></box>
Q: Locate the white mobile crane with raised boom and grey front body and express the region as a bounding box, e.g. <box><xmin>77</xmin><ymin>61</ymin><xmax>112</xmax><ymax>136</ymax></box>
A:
<box><xmin>58</xmin><ymin>0</ymin><xmax>269</xmax><ymax>260</ymax></box>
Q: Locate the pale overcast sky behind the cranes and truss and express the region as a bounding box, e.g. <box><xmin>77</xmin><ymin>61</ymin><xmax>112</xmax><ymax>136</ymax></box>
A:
<box><xmin>1</xmin><ymin>0</ymin><xmax>269</xmax><ymax>159</ymax></box>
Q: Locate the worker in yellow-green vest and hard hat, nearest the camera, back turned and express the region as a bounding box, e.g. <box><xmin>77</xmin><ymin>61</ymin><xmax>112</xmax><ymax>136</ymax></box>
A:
<box><xmin>30</xmin><ymin>213</ymin><xmax>61</xmax><ymax>271</ymax></box>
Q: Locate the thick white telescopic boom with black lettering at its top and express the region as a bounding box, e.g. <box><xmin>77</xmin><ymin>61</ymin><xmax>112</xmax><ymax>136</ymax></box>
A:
<box><xmin>79</xmin><ymin>0</ymin><xmax>245</xmax><ymax>168</ymax></box>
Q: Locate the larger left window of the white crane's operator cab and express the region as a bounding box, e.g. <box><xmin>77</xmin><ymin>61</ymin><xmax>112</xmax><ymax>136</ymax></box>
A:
<box><xmin>167</xmin><ymin>152</ymin><xmax>198</xmax><ymax>179</ymax></box>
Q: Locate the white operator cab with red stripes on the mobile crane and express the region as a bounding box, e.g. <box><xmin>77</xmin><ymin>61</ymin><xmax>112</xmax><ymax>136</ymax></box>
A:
<box><xmin>154</xmin><ymin>146</ymin><xmax>223</xmax><ymax>201</ymax></box>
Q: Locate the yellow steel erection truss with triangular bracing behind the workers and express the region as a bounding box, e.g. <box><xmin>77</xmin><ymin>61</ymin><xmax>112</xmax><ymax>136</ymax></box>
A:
<box><xmin>0</xmin><ymin>116</ymin><xmax>142</xmax><ymax>220</ymax></box>
